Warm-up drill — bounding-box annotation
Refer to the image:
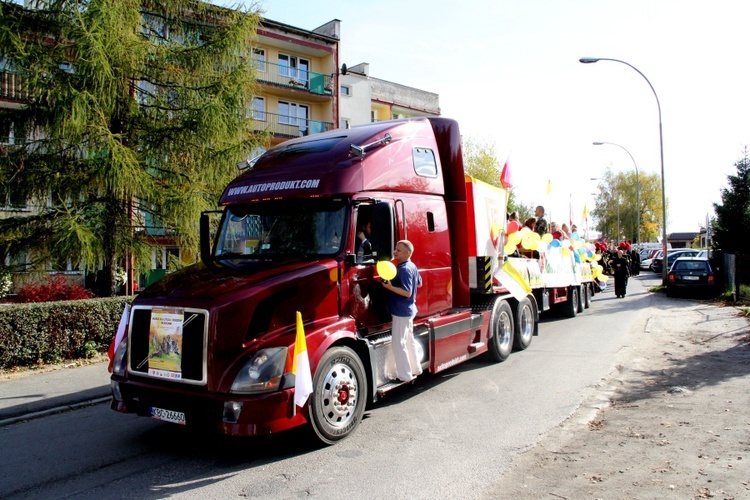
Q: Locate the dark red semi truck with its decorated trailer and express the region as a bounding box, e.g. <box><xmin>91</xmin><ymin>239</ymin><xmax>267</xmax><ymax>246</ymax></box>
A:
<box><xmin>111</xmin><ymin>118</ymin><xmax>595</xmax><ymax>444</ymax></box>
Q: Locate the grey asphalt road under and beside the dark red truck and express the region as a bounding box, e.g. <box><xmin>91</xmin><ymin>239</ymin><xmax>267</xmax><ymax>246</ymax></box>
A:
<box><xmin>0</xmin><ymin>273</ymin><xmax>659</xmax><ymax>499</ymax></box>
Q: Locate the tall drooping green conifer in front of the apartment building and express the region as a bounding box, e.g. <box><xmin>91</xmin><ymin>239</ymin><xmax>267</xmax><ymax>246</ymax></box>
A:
<box><xmin>0</xmin><ymin>0</ymin><xmax>260</xmax><ymax>295</ymax></box>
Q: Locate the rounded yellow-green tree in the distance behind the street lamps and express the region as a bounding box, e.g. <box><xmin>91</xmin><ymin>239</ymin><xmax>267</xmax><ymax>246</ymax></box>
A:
<box><xmin>591</xmin><ymin>169</ymin><xmax>662</xmax><ymax>242</ymax></box>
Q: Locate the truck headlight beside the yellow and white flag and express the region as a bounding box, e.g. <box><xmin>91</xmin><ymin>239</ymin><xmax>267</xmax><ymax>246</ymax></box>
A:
<box><xmin>229</xmin><ymin>347</ymin><xmax>288</xmax><ymax>394</ymax></box>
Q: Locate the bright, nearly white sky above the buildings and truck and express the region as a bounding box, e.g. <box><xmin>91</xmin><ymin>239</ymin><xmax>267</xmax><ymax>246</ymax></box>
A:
<box><xmin>223</xmin><ymin>0</ymin><xmax>750</xmax><ymax>236</ymax></box>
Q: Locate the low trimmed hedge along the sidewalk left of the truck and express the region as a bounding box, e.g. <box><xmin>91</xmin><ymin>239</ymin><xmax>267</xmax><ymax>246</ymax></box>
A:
<box><xmin>0</xmin><ymin>297</ymin><xmax>133</xmax><ymax>369</ymax></box>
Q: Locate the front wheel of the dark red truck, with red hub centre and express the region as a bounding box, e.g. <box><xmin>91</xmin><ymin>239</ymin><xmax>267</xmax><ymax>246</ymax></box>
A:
<box><xmin>309</xmin><ymin>347</ymin><xmax>367</xmax><ymax>444</ymax></box>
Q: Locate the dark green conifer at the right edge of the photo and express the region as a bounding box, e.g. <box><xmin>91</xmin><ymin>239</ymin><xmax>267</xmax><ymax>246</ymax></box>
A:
<box><xmin>712</xmin><ymin>149</ymin><xmax>750</xmax><ymax>254</ymax></box>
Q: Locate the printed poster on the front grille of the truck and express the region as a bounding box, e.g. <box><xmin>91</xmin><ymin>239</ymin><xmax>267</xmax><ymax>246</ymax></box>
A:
<box><xmin>148</xmin><ymin>308</ymin><xmax>185</xmax><ymax>380</ymax></box>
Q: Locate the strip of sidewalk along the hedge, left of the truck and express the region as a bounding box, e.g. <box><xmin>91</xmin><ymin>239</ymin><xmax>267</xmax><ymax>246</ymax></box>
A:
<box><xmin>0</xmin><ymin>361</ymin><xmax>111</xmax><ymax>425</ymax></box>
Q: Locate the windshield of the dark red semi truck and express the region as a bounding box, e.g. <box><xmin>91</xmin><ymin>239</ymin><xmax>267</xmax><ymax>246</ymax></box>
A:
<box><xmin>214</xmin><ymin>199</ymin><xmax>346</xmax><ymax>259</ymax></box>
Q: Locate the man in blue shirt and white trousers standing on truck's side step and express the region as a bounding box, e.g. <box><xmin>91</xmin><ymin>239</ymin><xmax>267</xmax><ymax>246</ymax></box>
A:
<box><xmin>383</xmin><ymin>240</ymin><xmax>422</xmax><ymax>382</ymax></box>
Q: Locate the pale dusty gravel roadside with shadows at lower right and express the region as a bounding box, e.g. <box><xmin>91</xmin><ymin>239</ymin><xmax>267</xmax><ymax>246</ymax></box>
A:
<box><xmin>488</xmin><ymin>297</ymin><xmax>750</xmax><ymax>499</ymax></box>
